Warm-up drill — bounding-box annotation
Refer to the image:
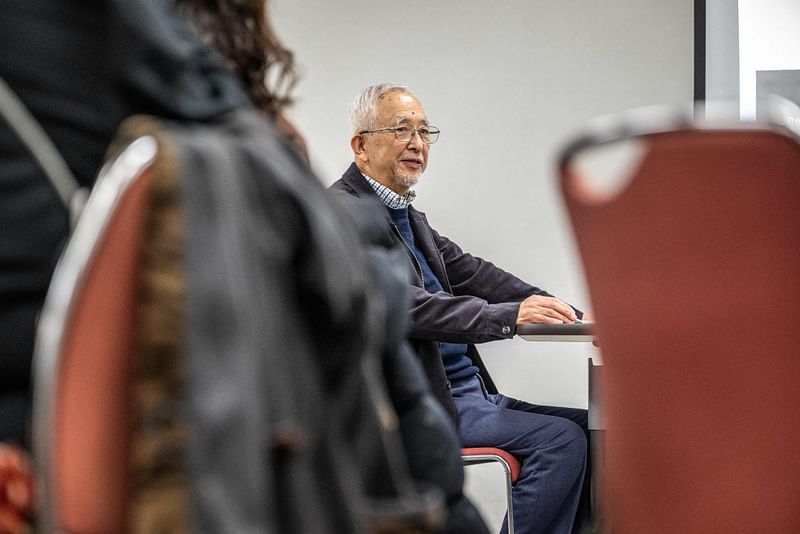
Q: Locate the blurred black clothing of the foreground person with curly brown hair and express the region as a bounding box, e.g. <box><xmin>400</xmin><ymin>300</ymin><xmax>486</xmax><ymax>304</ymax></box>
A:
<box><xmin>0</xmin><ymin>0</ymin><xmax>250</xmax><ymax>447</ymax></box>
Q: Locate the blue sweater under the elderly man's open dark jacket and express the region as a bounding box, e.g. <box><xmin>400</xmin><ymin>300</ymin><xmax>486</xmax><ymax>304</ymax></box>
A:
<box><xmin>386</xmin><ymin>208</ymin><xmax>478</xmax><ymax>382</ymax></box>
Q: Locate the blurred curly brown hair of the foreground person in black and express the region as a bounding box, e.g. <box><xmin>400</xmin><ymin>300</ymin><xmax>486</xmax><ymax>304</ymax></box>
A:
<box><xmin>178</xmin><ymin>0</ymin><xmax>297</xmax><ymax>114</ymax></box>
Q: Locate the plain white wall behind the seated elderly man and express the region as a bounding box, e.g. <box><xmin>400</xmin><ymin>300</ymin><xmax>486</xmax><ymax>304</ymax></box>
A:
<box><xmin>270</xmin><ymin>0</ymin><xmax>693</xmax><ymax>528</ymax></box>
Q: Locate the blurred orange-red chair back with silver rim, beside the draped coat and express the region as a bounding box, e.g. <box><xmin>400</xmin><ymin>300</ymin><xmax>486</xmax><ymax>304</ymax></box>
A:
<box><xmin>34</xmin><ymin>137</ymin><xmax>161</xmax><ymax>532</ymax></box>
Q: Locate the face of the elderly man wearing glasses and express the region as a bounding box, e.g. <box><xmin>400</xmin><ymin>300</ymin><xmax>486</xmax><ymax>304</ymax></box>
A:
<box><xmin>351</xmin><ymin>91</ymin><xmax>430</xmax><ymax>194</ymax></box>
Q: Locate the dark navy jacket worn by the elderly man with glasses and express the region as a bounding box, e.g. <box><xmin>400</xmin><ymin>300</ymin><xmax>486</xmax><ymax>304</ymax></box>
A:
<box><xmin>330</xmin><ymin>163</ymin><xmax>572</xmax><ymax>421</ymax></box>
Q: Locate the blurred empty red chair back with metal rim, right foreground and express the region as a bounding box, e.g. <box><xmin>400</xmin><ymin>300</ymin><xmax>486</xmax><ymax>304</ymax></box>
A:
<box><xmin>560</xmin><ymin>107</ymin><xmax>800</xmax><ymax>534</ymax></box>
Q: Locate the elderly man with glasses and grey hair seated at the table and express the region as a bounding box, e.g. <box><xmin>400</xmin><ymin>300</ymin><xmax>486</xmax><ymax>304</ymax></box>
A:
<box><xmin>331</xmin><ymin>83</ymin><xmax>588</xmax><ymax>533</ymax></box>
